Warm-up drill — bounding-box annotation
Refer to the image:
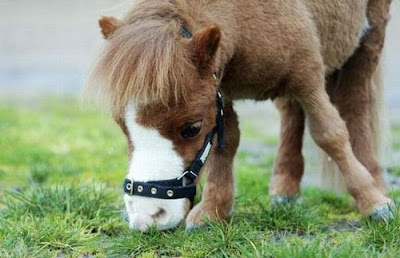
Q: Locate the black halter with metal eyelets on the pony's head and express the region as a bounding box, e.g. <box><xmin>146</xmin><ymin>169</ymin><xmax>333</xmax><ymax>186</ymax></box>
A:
<box><xmin>124</xmin><ymin>75</ymin><xmax>225</xmax><ymax>203</ymax></box>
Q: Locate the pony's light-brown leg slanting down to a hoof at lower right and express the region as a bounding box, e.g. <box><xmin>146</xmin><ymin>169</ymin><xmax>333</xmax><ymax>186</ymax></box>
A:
<box><xmin>291</xmin><ymin>61</ymin><xmax>393</xmax><ymax>219</ymax></box>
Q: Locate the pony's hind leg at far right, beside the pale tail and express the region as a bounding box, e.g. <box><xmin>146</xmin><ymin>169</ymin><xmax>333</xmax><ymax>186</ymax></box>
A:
<box><xmin>328</xmin><ymin>0</ymin><xmax>390</xmax><ymax>196</ymax></box>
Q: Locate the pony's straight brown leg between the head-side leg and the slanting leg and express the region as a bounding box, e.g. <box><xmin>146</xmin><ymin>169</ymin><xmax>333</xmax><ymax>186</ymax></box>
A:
<box><xmin>269</xmin><ymin>97</ymin><xmax>305</xmax><ymax>204</ymax></box>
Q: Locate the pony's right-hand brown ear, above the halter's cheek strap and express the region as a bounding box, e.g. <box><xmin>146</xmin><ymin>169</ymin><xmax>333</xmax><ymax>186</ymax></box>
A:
<box><xmin>192</xmin><ymin>25</ymin><xmax>221</xmax><ymax>74</ymax></box>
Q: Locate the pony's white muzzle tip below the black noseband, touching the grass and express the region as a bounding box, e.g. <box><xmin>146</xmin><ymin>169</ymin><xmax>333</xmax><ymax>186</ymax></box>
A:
<box><xmin>124</xmin><ymin>196</ymin><xmax>190</xmax><ymax>232</ymax></box>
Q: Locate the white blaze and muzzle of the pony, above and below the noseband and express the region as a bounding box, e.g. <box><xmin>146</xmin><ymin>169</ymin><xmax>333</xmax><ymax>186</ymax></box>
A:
<box><xmin>125</xmin><ymin>104</ymin><xmax>185</xmax><ymax>231</ymax></box>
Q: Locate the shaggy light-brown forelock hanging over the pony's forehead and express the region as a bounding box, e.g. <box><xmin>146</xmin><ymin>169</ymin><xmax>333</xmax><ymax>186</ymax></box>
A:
<box><xmin>84</xmin><ymin>0</ymin><xmax>198</xmax><ymax>113</ymax></box>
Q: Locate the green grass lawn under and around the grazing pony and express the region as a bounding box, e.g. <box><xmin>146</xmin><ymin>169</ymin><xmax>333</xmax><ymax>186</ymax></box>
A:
<box><xmin>0</xmin><ymin>98</ymin><xmax>400</xmax><ymax>257</ymax></box>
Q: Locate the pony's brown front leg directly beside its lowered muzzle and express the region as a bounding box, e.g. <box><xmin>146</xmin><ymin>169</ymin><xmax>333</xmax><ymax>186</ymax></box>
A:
<box><xmin>186</xmin><ymin>103</ymin><xmax>240</xmax><ymax>230</ymax></box>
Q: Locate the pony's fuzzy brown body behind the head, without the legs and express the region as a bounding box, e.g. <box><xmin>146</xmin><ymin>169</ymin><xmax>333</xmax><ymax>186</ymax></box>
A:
<box><xmin>221</xmin><ymin>0</ymin><xmax>368</xmax><ymax>99</ymax></box>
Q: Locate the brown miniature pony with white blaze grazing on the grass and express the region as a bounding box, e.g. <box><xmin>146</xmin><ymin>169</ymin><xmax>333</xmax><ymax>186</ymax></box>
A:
<box><xmin>89</xmin><ymin>0</ymin><xmax>392</xmax><ymax>231</ymax></box>
